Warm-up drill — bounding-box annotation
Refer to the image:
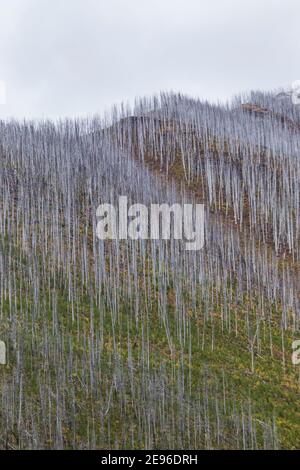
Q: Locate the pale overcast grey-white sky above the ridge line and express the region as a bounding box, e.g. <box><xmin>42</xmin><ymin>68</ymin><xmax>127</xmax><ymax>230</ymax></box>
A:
<box><xmin>0</xmin><ymin>0</ymin><xmax>300</xmax><ymax>119</ymax></box>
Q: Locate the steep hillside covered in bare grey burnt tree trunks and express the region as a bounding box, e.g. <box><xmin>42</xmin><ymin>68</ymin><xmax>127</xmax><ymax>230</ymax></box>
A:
<box><xmin>0</xmin><ymin>93</ymin><xmax>300</xmax><ymax>449</ymax></box>
